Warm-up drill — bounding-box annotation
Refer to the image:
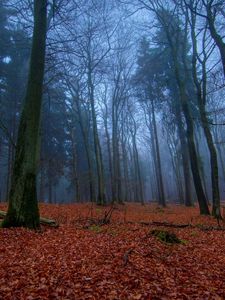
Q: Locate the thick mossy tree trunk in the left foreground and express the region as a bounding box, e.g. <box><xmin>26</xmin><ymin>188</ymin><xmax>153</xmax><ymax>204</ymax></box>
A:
<box><xmin>2</xmin><ymin>0</ymin><xmax>47</xmax><ymax>229</ymax></box>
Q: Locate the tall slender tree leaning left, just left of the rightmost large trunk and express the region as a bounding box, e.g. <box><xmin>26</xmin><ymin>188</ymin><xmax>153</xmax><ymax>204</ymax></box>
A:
<box><xmin>134</xmin><ymin>0</ymin><xmax>209</xmax><ymax>215</ymax></box>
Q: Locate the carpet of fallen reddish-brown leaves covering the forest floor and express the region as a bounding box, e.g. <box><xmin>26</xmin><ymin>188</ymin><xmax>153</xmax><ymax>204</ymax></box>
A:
<box><xmin>0</xmin><ymin>204</ymin><xmax>225</xmax><ymax>300</ymax></box>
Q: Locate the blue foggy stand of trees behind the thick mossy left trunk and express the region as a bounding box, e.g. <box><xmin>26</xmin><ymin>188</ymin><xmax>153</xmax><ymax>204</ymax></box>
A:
<box><xmin>0</xmin><ymin>0</ymin><xmax>225</xmax><ymax>210</ymax></box>
